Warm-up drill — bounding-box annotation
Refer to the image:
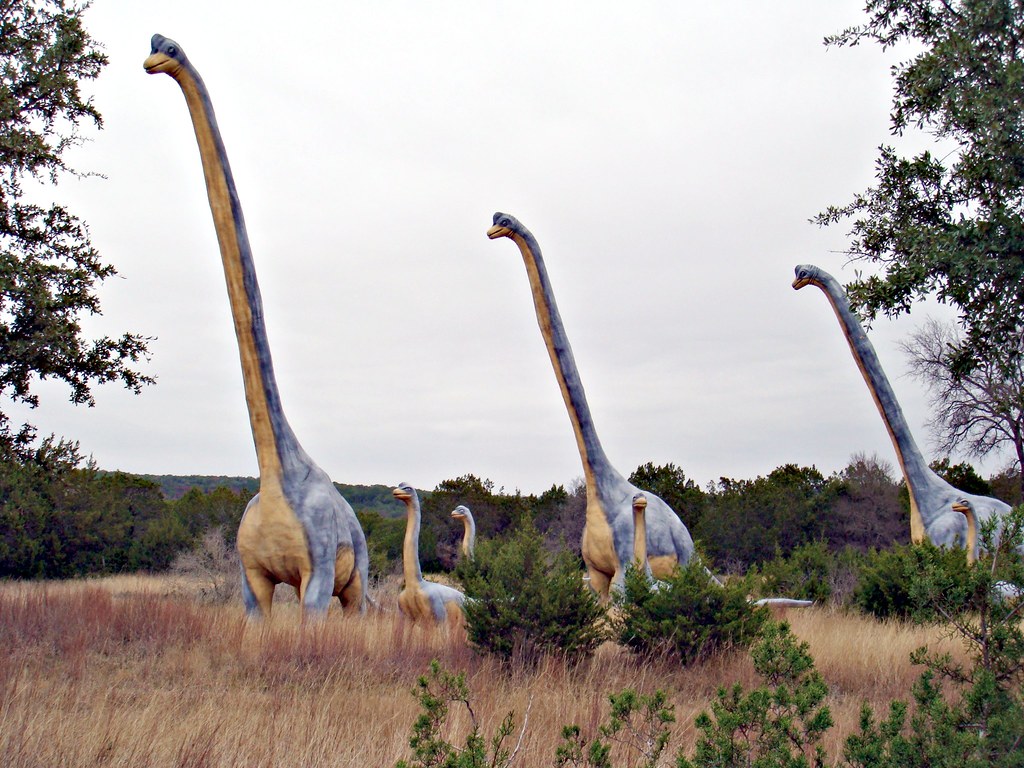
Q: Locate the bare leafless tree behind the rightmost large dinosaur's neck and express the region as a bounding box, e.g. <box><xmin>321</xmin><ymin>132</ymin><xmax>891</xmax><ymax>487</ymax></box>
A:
<box><xmin>900</xmin><ymin>318</ymin><xmax>1024</xmax><ymax>499</ymax></box>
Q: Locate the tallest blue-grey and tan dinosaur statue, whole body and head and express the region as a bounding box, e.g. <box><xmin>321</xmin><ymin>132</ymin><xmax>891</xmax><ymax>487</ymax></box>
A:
<box><xmin>144</xmin><ymin>35</ymin><xmax>369</xmax><ymax>617</ymax></box>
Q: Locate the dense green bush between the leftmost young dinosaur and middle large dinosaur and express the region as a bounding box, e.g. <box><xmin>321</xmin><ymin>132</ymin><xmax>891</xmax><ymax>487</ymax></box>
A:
<box><xmin>456</xmin><ymin>520</ymin><xmax>607</xmax><ymax>664</ymax></box>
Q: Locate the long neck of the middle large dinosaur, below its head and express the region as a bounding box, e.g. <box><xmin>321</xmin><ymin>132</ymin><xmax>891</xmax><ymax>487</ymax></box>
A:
<box><xmin>512</xmin><ymin>232</ymin><xmax>614</xmax><ymax>494</ymax></box>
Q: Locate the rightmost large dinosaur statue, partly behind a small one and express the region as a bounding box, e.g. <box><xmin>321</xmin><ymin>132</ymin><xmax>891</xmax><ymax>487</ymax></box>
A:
<box><xmin>793</xmin><ymin>264</ymin><xmax>1010</xmax><ymax>556</ymax></box>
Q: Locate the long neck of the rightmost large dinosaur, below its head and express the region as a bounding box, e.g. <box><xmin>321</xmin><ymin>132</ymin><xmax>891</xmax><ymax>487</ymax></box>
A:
<box><xmin>814</xmin><ymin>275</ymin><xmax>931</xmax><ymax>543</ymax></box>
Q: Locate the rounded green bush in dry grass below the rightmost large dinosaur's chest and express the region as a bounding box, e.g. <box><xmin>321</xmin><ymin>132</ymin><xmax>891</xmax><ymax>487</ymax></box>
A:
<box><xmin>853</xmin><ymin>543</ymin><xmax>968</xmax><ymax>622</ymax></box>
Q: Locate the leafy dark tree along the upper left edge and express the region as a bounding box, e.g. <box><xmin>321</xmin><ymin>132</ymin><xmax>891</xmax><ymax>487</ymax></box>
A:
<box><xmin>0</xmin><ymin>0</ymin><xmax>152</xmax><ymax>457</ymax></box>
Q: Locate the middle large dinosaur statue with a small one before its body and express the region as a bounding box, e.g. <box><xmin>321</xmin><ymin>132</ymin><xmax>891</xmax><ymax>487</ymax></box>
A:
<box><xmin>487</xmin><ymin>213</ymin><xmax>693</xmax><ymax>598</ymax></box>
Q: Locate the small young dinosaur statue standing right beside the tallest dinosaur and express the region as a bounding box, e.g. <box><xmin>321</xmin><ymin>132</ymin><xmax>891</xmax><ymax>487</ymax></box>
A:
<box><xmin>391</xmin><ymin>482</ymin><xmax>466</xmax><ymax>624</ymax></box>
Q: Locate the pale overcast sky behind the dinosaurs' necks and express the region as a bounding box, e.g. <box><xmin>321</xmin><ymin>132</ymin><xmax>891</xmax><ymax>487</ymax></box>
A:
<box><xmin>9</xmin><ymin>0</ymin><xmax>1000</xmax><ymax>493</ymax></box>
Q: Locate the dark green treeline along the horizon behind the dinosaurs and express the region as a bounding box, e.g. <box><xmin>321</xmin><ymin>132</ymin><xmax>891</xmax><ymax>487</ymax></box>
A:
<box><xmin>0</xmin><ymin>451</ymin><xmax>1020</xmax><ymax>579</ymax></box>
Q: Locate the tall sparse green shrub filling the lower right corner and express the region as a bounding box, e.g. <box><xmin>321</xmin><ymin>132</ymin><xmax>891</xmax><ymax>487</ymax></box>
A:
<box><xmin>843</xmin><ymin>507</ymin><xmax>1024</xmax><ymax>768</ymax></box>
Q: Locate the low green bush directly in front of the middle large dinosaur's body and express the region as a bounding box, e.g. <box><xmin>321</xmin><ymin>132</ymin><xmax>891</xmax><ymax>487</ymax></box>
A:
<box><xmin>615</xmin><ymin>557</ymin><xmax>768</xmax><ymax>664</ymax></box>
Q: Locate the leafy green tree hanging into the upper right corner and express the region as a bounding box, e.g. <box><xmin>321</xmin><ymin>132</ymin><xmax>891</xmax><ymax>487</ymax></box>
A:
<box><xmin>816</xmin><ymin>0</ymin><xmax>1024</xmax><ymax>369</ymax></box>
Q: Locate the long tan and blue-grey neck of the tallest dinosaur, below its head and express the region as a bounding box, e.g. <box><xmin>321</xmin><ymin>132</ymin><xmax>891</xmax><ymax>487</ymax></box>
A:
<box><xmin>165</xmin><ymin>66</ymin><xmax>300</xmax><ymax>479</ymax></box>
